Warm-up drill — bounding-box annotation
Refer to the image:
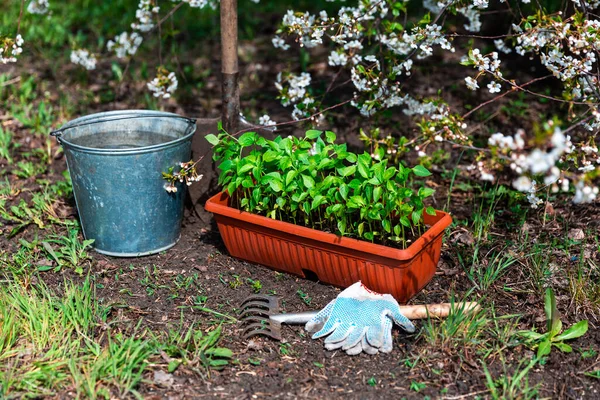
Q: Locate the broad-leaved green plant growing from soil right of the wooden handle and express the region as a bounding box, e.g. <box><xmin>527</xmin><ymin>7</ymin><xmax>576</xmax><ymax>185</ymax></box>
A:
<box><xmin>518</xmin><ymin>288</ymin><xmax>588</xmax><ymax>359</ymax></box>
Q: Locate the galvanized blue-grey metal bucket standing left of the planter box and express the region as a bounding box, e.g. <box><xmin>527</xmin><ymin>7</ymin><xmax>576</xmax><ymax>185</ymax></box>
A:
<box><xmin>51</xmin><ymin>110</ymin><xmax>196</xmax><ymax>257</ymax></box>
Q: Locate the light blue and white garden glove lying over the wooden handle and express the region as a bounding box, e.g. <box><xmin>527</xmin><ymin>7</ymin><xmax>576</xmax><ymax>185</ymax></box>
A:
<box><xmin>305</xmin><ymin>282</ymin><xmax>415</xmax><ymax>355</ymax></box>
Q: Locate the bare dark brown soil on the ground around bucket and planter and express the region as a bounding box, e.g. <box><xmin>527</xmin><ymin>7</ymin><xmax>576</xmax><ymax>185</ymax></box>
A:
<box><xmin>0</xmin><ymin>35</ymin><xmax>600</xmax><ymax>399</ymax></box>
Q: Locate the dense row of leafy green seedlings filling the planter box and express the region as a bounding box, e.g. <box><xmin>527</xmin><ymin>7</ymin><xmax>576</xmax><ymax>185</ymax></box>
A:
<box><xmin>206</xmin><ymin>129</ymin><xmax>435</xmax><ymax>247</ymax></box>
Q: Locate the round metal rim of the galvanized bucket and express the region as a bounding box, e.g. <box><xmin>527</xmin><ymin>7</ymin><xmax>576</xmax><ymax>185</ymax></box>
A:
<box><xmin>50</xmin><ymin>110</ymin><xmax>197</xmax><ymax>155</ymax></box>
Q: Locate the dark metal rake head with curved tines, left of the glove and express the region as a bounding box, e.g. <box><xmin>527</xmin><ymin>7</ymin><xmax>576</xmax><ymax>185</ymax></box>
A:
<box><xmin>240</xmin><ymin>294</ymin><xmax>282</xmax><ymax>340</ymax></box>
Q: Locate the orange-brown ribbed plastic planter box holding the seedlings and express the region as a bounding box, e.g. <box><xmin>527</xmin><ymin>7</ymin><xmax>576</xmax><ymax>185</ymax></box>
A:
<box><xmin>205</xmin><ymin>193</ymin><xmax>452</xmax><ymax>303</ymax></box>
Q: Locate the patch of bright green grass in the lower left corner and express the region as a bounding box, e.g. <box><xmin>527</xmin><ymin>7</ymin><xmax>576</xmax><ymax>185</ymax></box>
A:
<box><xmin>0</xmin><ymin>279</ymin><xmax>233</xmax><ymax>399</ymax></box>
